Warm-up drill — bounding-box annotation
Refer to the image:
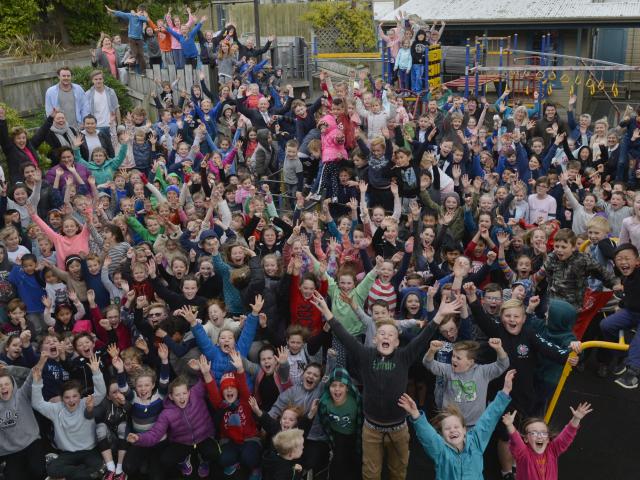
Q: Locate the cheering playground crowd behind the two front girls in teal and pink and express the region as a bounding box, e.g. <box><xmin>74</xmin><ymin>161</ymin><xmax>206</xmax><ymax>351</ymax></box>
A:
<box><xmin>0</xmin><ymin>6</ymin><xmax>640</xmax><ymax>480</ymax></box>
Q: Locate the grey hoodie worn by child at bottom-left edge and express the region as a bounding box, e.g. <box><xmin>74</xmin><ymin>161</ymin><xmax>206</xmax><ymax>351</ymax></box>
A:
<box><xmin>0</xmin><ymin>374</ymin><xmax>40</xmax><ymax>457</ymax></box>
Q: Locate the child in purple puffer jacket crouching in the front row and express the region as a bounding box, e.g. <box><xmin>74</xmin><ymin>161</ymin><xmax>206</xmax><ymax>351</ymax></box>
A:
<box><xmin>127</xmin><ymin>377</ymin><xmax>220</xmax><ymax>478</ymax></box>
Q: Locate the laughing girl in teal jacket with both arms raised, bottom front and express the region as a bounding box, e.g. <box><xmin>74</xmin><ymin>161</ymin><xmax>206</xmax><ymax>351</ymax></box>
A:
<box><xmin>398</xmin><ymin>370</ymin><xmax>516</xmax><ymax>480</ymax></box>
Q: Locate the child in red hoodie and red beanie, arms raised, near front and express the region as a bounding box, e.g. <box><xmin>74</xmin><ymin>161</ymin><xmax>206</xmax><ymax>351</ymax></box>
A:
<box><xmin>206</xmin><ymin>351</ymin><xmax>262</xmax><ymax>480</ymax></box>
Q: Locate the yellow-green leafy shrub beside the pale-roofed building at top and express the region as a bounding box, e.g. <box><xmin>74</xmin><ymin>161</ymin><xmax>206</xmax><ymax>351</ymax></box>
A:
<box><xmin>302</xmin><ymin>2</ymin><xmax>376</xmax><ymax>52</ymax></box>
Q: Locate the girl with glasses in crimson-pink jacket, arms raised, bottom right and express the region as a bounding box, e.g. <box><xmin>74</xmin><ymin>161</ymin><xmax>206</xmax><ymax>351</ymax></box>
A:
<box><xmin>502</xmin><ymin>402</ymin><xmax>592</xmax><ymax>480</ymax></box>
